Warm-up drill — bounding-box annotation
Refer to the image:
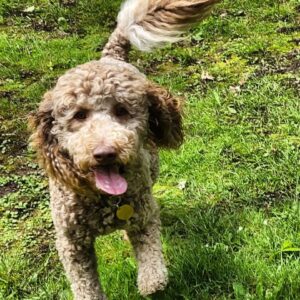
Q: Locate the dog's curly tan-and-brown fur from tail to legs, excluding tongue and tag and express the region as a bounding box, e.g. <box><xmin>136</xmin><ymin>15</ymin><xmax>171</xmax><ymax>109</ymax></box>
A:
<box><xmin>31</xmin><ymin>0</ymin><xmax>216</xmax><ymax>300</ymax></box>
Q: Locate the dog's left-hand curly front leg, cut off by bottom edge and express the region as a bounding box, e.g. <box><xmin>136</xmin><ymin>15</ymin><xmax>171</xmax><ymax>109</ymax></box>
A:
<box><xmin>56</xmin><ymin>235</ymin><xmax>106</xmax><ymax>300</ymax></box>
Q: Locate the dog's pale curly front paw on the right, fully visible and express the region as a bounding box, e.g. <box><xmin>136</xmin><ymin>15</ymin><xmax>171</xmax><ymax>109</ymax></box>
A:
<box><xmin>138</xmin><ymin>265</ymin><xmax>168</xmax><ymax>296</ymax></box>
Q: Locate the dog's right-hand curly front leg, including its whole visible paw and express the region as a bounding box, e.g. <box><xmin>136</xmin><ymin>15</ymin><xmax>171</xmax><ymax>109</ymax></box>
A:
<box><xmin>127</xmin><ymin>216</ymin><xmax>168</xmax><ymax>296</ymax></box>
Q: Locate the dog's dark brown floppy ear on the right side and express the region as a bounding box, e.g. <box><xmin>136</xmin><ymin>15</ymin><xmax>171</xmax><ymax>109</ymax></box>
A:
<box><xmin>147</xmin><ymin>83</ymin><xmax>183</xmax><ymax>148</ymax></box>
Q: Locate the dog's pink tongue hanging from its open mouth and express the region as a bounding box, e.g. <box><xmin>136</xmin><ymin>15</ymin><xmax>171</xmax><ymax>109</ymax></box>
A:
<box><xmin>94</xmin><ymin>168</ymin><xmax>127</xmax><ymax>195</ymax></box>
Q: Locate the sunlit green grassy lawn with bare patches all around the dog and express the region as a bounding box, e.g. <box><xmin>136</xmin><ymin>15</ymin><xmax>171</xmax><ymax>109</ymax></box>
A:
<box><xmin>0</xmin><ymin>0</ymin><xmax>300</xmax><ymax>300</ymax></box>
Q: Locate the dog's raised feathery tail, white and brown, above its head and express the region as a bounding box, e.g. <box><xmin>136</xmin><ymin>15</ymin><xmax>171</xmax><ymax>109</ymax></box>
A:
<box><xmin>102</xmin><ymin>0</ymin><xmax>219</xmax><ymax>60</ymax></box>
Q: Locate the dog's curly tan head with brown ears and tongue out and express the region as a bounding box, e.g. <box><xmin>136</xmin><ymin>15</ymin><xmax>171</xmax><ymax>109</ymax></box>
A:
<box><xmin>32</xmin><ymin>61</ymin><xmax>182</xmax><ymax>195</ymax></box>
